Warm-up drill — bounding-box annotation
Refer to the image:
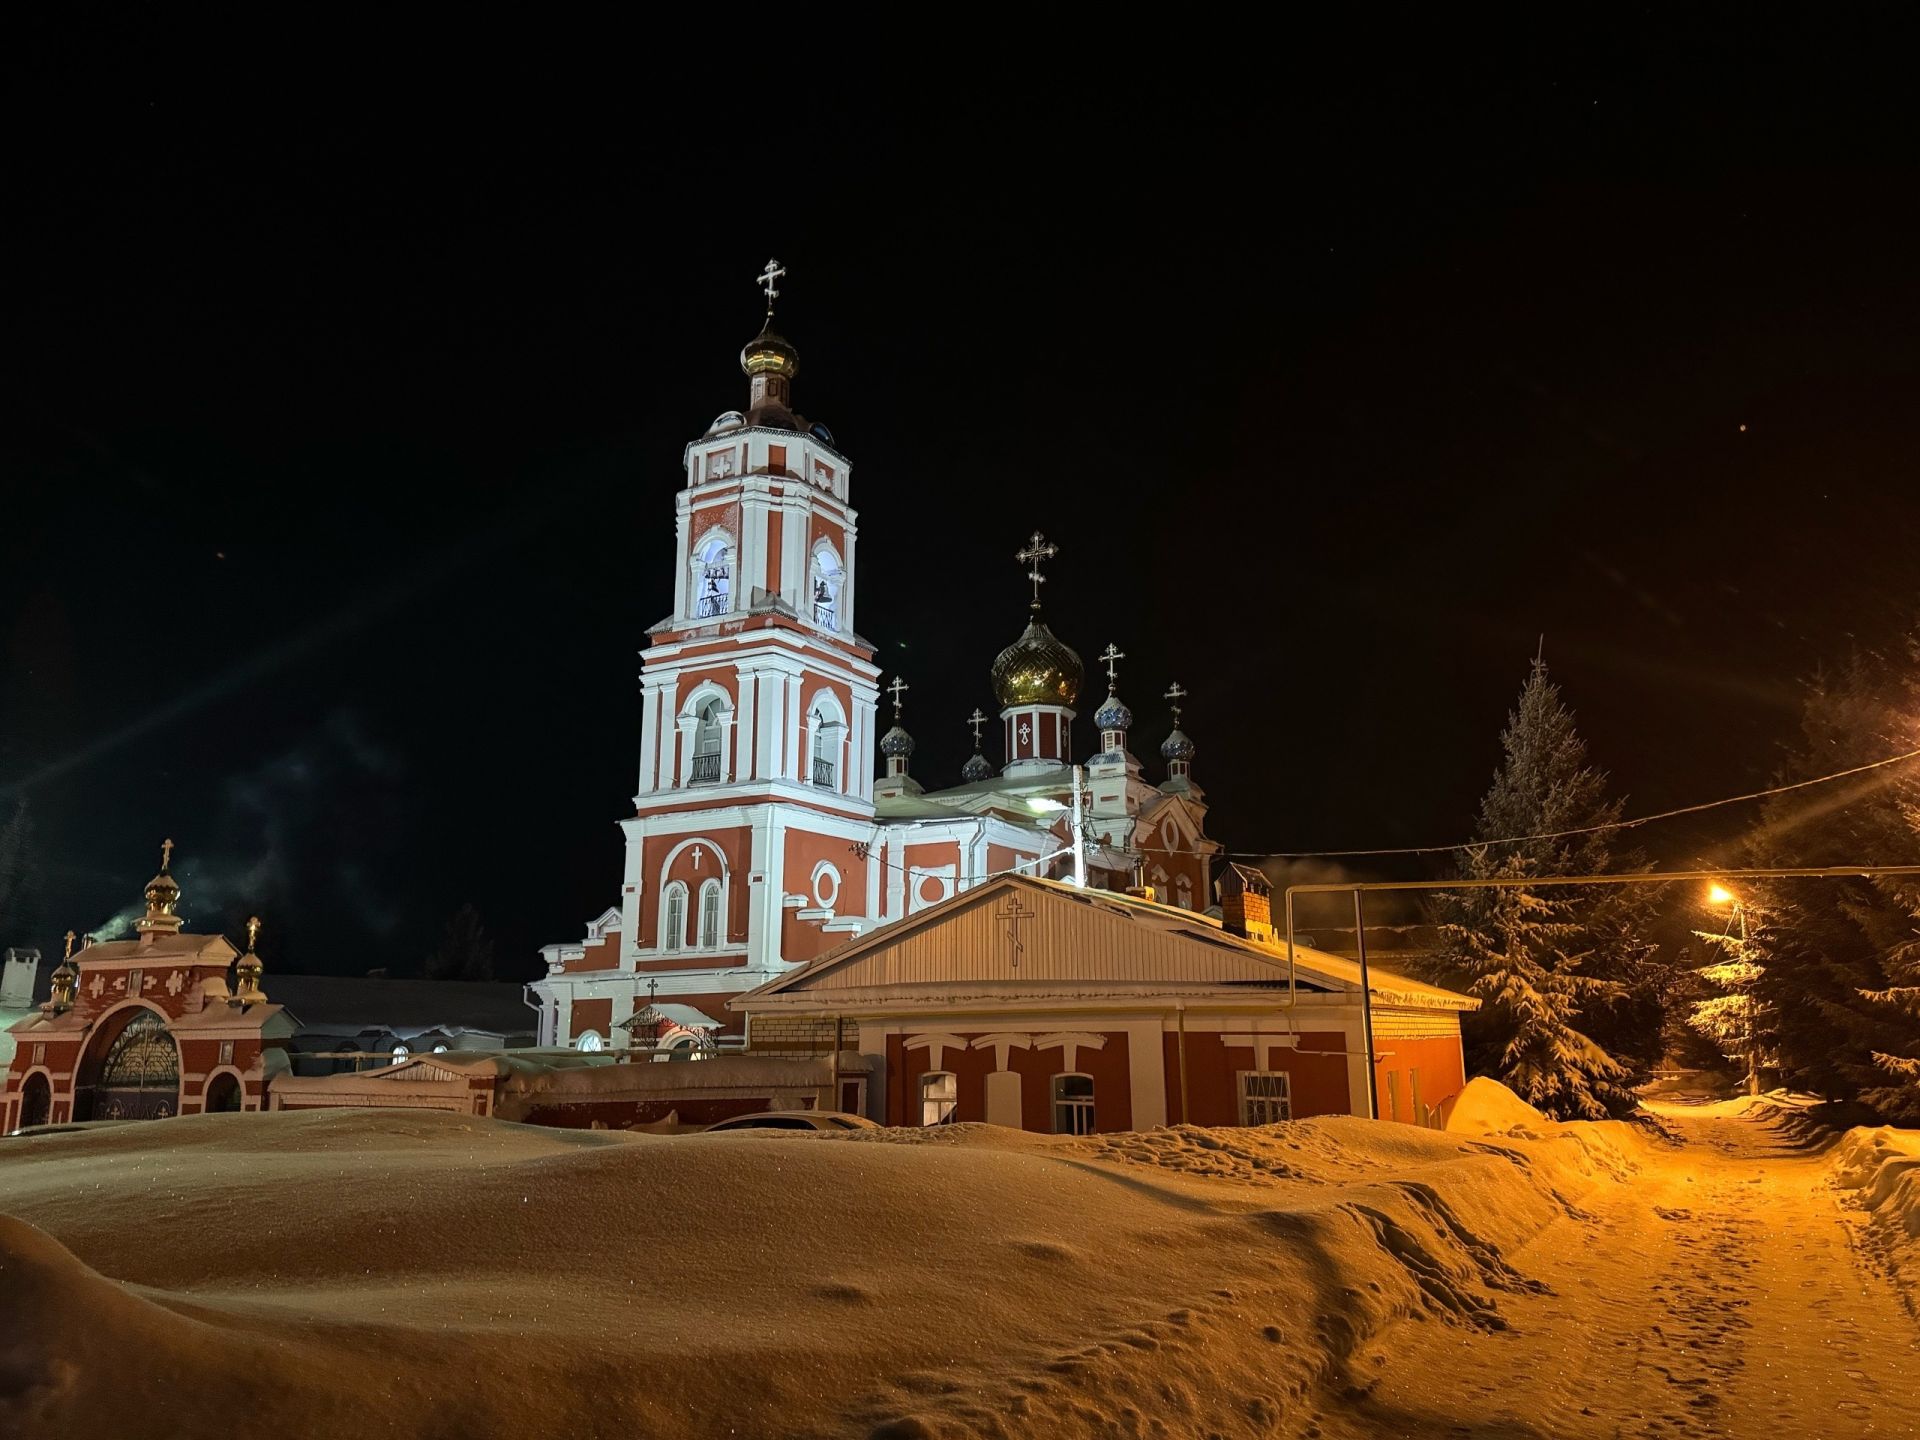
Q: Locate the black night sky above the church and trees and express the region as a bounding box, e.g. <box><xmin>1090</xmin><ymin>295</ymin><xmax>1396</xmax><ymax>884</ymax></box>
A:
<box><xmin>0</xmin><ymin>19</ymin><xmax>1920</xmax><ymax>973</ymax></box>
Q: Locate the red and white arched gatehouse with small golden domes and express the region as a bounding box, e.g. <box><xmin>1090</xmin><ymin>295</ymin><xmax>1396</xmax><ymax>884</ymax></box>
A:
<box><xmin>0</xmin><ymin>841</ymin><xmax>296</xmax><ymax>1133</ymax></box>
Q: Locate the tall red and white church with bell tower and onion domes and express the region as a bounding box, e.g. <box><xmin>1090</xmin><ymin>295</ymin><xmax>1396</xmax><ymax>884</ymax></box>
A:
<box><xmin>530</xmin><ymin>261</ymin><xmax>1219</xmax><ymax>1056</ymax></box>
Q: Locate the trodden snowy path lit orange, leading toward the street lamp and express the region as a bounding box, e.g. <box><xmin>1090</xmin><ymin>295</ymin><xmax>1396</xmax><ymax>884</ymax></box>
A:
<box><xmin>1300</xmin><ymin>1112</ymin><xmax>1920</xmax><ymax>1440</ymax></box>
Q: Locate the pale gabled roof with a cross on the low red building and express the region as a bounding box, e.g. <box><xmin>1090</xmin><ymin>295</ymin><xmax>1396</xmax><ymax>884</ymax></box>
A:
<box><xmin>732</xmin><ymin>876</ymin><xmax>1476</xmax><ymax>1012</ymax></box>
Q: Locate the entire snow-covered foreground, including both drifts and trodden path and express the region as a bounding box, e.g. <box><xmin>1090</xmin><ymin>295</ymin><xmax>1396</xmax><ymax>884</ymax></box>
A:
<box><xmin>0</xmin><ymin>1081</ymin><xmax>1920</xmax><ymax>1440</ymax></box>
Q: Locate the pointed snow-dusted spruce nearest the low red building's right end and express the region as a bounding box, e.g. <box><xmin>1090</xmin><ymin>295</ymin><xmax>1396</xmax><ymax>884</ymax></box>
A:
<box><xmin>1428</xmin><ymin>660</ymin><xmax>1661</xmax><ymax>1119</ymax></box>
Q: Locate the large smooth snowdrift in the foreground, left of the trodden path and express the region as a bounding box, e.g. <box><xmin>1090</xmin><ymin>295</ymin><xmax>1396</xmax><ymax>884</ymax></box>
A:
<box><xmin>0</xmin><ymin>1096</ymin><xmax>1638</xmax><ymax>1440</ymax></box>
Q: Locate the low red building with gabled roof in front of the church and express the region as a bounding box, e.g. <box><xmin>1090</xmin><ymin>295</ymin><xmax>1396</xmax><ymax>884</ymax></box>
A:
<box><xmin>729</xmin><ymin>868</ymin><xmax>1478</xmax><ymax>1135</ymax></box>
